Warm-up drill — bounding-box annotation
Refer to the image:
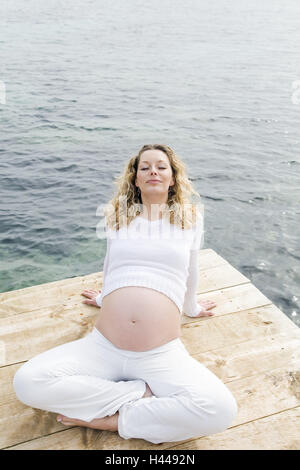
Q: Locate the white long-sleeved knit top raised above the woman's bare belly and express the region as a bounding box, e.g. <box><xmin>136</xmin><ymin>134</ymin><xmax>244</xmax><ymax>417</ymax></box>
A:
<box><xmin>96</xmin><ymin>215</ymin><xmax>204</xmax><ymax>317</ymax></box>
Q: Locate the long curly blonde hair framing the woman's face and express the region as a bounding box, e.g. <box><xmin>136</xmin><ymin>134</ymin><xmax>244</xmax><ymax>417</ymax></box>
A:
<box><xmin>104</xmin><ymin>144</ymin><xmax>202</xmax><ymax>231</ymax></box>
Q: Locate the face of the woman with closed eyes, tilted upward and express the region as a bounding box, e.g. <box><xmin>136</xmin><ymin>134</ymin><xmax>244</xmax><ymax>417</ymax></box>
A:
<box><xmin>135</xmin><ymin>150</ymin><xmax>175</xmax><ymax>199</ymax></box>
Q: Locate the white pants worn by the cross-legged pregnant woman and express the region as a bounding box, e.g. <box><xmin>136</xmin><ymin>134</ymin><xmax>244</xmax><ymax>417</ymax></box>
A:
<box><xmin>13</xmin><ymin>328</ymin><xmax>237</xmax><ymax>444</ymax></box>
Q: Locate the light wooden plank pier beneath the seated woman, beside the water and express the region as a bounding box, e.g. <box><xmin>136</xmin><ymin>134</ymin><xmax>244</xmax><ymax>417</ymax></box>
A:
<box><xmin>0</xmin><ymin>249</ymin><xmax>300</xmax><ymax>450</ymax></box>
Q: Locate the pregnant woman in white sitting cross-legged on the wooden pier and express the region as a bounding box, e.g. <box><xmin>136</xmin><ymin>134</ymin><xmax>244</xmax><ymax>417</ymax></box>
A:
<box><xmin>13</xmin><ymin>144</ymin><xmax>237</xmax><ymax>444</ymax></box>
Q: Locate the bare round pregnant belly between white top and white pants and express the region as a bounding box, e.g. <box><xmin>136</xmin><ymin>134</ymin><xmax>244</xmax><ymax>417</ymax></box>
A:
<box><xmin>95</xmin><ymin>286</ymin><xmax>181</xmax><ymax>351</ymax></box>
